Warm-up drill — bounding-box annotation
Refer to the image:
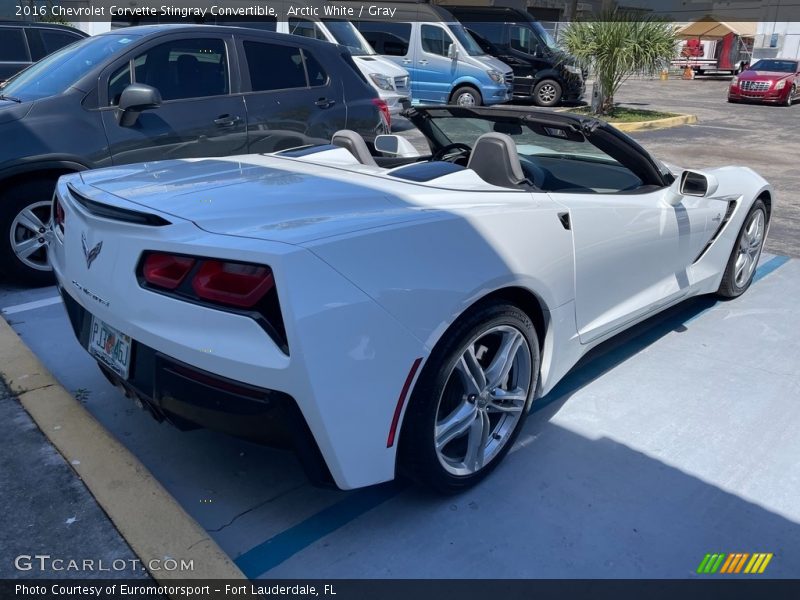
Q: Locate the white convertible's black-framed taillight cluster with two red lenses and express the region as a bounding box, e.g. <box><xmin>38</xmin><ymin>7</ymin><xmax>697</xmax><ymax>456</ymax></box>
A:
<box><xmin>136</xmin><ymin>251</ymin><xmax>289</xmax><ymax>354</ymax></box>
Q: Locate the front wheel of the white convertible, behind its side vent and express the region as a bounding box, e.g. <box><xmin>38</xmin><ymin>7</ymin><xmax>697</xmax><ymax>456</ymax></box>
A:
<box><xmin>717</xmin><ymin>199</ymin><xmax>768</xmax><ymax>298</ymax></box>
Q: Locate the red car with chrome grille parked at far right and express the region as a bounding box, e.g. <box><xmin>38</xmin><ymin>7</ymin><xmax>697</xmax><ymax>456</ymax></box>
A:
<box><xmin>728</xmin><ymin>58</ymin><xmax>800</xmax><ymax>106</ymax></box>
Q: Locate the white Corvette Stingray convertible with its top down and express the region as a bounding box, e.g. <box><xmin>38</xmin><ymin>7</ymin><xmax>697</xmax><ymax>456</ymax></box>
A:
<box><xmin>48</xmin><ymin>107</ymin><xmax>773</xmax><ymax>491</ymax></box>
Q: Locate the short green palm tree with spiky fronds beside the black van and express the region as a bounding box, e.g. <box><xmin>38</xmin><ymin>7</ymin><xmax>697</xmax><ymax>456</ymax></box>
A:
<box><xmin>562</xmin><ymin>11</ymin><xmax>678</xmax><ymax>115</ymax></box>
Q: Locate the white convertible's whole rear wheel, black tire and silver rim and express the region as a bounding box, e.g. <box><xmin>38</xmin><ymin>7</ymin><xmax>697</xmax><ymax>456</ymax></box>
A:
<box><xmin>399</xmin><ymin>302</ymin><xmax>539</xmax><ymax>493</ymax></box>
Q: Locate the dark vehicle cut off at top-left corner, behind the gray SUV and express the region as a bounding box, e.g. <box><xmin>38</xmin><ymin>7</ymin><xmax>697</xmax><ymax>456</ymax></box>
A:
<box><xmin>0</xmin><ymin>21</ymin><xmax>86</xmax><ymax>83</ymax></box>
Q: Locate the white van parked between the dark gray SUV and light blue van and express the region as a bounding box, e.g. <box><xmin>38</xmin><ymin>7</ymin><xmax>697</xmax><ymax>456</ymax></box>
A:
<box><xmin>277</xmin><ymin>17</ymin><xmax>411</xmax><ymax>115</ymax></box>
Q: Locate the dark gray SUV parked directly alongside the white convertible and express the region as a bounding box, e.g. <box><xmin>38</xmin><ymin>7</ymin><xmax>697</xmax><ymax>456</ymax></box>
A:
<box><xmin>0</xmin><ymin>25</ymin><xmax>388</xmax><ymax>285</ymax></box>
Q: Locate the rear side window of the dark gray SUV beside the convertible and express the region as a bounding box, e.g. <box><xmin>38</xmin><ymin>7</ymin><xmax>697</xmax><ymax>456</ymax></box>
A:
<box><xmin>243</xmin><ymin>41</ymin><xmax>328</xmax><ymax>92</ymax></box>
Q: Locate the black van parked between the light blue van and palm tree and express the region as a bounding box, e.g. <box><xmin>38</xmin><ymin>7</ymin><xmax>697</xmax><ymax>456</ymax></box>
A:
<box><xmin>447</xmin><ymin>6</ymin><xmax>586</xmax><ymax>106</ymax></box>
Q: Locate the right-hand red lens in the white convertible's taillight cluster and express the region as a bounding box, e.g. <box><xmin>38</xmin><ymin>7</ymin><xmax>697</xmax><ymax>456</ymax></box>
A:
<box><xmin>192</xmin><ymin>260</ymin><xmax>275</xmax><ymax>308</ymax></box>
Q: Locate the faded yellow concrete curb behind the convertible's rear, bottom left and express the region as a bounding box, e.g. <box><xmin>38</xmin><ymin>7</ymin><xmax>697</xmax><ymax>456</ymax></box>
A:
<box><xmin>0</xmin><ymin>318</ymin><xmax>246</xmax><ymax>583</ymax></box>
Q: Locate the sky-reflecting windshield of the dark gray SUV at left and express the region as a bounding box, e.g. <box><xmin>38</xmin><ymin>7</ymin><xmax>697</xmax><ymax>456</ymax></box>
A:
<box><xmin>2</xmin><ymin>35</ymin><xmax>138</xmax><ymax>100</ymax></box>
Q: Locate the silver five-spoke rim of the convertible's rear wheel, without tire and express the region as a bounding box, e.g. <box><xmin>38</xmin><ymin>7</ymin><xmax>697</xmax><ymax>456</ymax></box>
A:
<box><xmin>434</xmin><ymin>325</ymin><xmax>533</xmax><ymax>476</ymax></box>
